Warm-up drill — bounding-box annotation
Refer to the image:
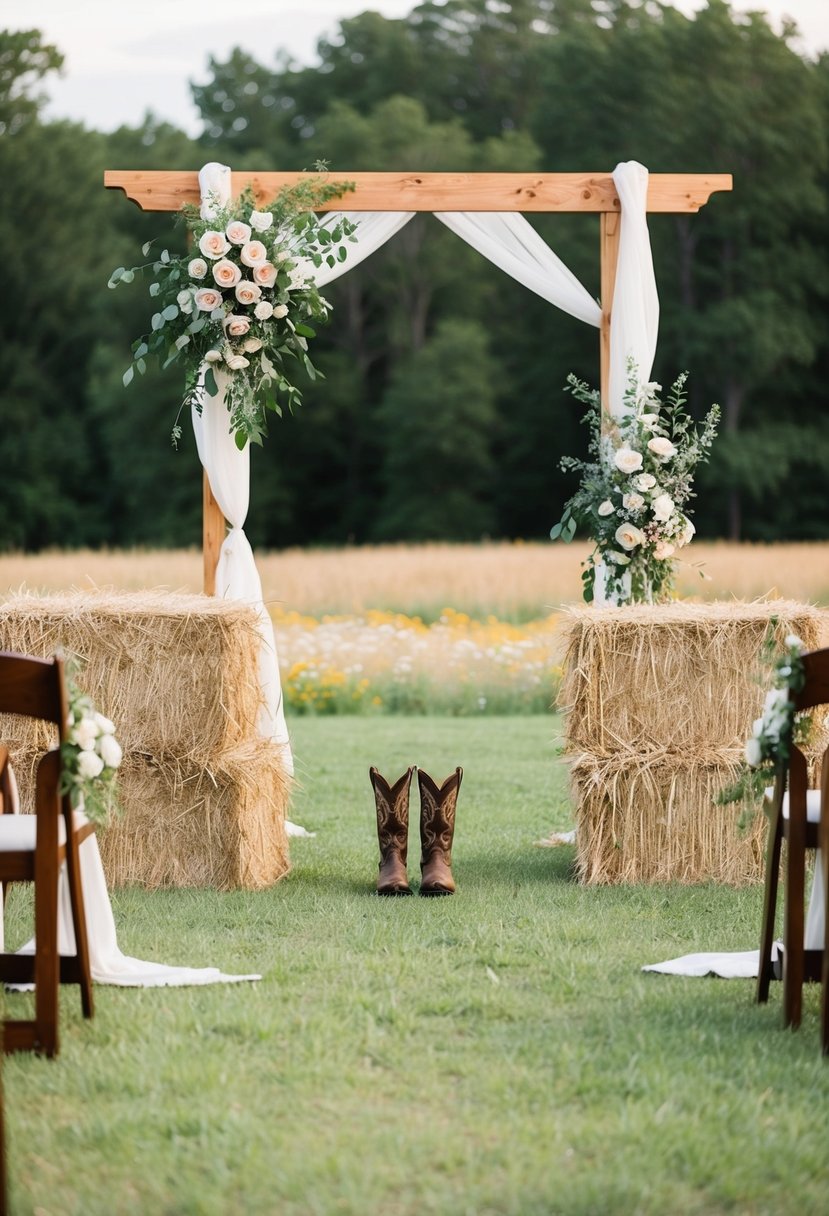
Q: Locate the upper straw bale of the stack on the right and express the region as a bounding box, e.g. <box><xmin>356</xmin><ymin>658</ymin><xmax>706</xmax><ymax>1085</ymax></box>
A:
<box><xmin>559</xmin><ymin>599</ymin><xmax>829</xmax><ymax>758</ymax></box>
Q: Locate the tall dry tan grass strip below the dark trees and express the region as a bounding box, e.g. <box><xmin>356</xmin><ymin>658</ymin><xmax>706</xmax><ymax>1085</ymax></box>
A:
<box><xmin>0</xmin><ymin>541</ymin><xmax>829</xmax><ymax>620</ymax></box>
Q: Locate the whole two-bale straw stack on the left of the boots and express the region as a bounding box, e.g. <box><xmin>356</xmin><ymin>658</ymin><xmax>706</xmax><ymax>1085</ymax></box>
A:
<box><xmin>0</xmin><ymin>591</ymin><xmax>291</xmax><ymax>890</ymax></box>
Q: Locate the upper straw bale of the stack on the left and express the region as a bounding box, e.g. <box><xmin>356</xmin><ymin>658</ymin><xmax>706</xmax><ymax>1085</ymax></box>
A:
<box><xmin>0</xmin><ymin>590</ymin><xmax>261</xmax><ymax>766</ymax></box>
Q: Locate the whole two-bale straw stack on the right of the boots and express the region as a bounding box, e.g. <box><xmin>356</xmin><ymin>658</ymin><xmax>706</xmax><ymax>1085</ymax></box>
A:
<box><xmin>559</xmin><ymin>601</ymin><xmax>825</xmax><ymax>884</ymax></box>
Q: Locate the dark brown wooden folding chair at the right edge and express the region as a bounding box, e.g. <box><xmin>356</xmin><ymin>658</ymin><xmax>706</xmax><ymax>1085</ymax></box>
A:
<box><xmin>757</xmin><ymin>649</ymin><xmax>829</xmax><ymax>1053</ymax></box>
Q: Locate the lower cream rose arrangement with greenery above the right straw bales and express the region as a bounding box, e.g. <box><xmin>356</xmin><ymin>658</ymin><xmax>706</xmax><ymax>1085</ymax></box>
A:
<box><xmin>549</xmin><ymin>364</ymin><xmax>720</xmax><ymax>603</ymax></box>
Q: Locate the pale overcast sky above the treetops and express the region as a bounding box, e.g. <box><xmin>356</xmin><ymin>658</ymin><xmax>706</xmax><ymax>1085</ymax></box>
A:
<box><xmin>11</xmin><ymin>0</ymin><xmax>829</xmax><ymax>135</ymax></box>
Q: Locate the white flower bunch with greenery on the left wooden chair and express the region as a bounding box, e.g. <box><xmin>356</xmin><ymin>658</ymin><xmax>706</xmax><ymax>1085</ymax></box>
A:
<box><xmin>61</xmin><ymin>668</ymin><xmax>123</xmax><ymax>826</ymax></box>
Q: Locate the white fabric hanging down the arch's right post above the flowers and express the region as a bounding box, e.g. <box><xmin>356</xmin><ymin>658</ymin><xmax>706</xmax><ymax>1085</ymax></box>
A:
<box><xmin>608</xmin><ymin>161</ymin><xmax>659</xmax><ymax>417</ymax></box>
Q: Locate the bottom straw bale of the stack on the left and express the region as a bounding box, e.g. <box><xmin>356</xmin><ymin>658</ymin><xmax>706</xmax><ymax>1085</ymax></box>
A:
<box><xmin>6</xmin><ymin>739</ymin><xmax>291</xmax><ymax>890</ymax></box>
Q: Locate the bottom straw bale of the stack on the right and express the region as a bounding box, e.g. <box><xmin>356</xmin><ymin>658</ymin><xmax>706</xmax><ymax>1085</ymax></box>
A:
<box><xmin>571</xmin><ymin>751</ymin><xmax>767</xmax><ymax>885</ymax></box>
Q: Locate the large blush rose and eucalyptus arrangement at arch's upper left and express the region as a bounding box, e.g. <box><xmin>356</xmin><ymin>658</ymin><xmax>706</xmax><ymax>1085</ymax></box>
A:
<box><xmin>108</xmin><ymin>165</ymin><xmax>355</xmax><ymax>447</ymax></box>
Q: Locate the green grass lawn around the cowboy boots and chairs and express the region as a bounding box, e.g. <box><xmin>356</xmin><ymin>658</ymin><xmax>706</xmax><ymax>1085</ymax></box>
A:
<box><xmin>4</xmin><ymin>716</ymin><xmax>829</xmax><ymax>1216</ymax></box>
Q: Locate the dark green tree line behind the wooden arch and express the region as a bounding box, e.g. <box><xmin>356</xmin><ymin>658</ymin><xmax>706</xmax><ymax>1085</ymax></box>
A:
<box><xmin>0</xmin><ymin>0</ymin><xmax>829</xmax><ymax>550</ymax></box>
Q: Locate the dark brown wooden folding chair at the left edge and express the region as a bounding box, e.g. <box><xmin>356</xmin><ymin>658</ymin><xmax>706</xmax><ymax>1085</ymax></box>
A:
<box><xmin>0</xmin><ymin>652</ymin><xmax>95</xmax><ymax>1055</ymax></box>
